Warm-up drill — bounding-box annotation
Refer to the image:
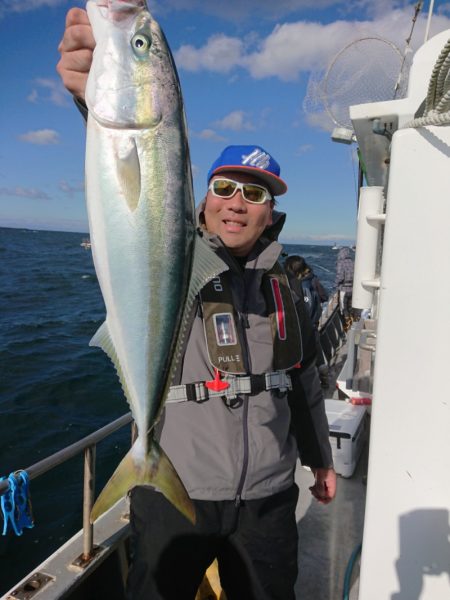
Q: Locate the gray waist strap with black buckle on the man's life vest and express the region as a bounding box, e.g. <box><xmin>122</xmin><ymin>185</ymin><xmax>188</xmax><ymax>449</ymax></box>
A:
<box><xmin>166</xmin><ymin>371</ymin><xmax>292</xmax><ymax>403</ymax></box>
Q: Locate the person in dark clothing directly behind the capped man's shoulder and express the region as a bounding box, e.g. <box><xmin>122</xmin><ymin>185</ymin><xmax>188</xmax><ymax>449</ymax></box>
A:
<box><xmin>284</xmin><ymin>254</ymin><xmax>328</xmax><ymax>389</ymax></box>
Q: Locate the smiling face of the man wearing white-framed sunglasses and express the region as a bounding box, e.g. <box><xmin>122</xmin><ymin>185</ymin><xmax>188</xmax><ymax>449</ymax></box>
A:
<box><xmin>204</xmin><ymin>171</ymin><xmax>272</xmax><ymax>256</ymax></box>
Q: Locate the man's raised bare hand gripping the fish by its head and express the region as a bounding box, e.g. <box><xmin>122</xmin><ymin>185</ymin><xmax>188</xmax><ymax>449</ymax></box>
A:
<box><xmin>56</xmin><ymin>8</ymin><xmax>95</xmax><ymax>100</ymax></box>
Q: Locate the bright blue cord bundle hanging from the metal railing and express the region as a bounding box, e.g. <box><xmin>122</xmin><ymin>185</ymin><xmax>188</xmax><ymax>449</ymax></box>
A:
<box><xmin>0</xmin><ymin>471</ymin><xmax>34</xmax><ymax>535</ymax></box>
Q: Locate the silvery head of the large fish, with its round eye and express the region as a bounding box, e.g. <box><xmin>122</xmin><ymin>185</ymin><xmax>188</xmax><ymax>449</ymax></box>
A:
<box><xmin>85</xmin><ymin>0</ymin><xmax>182</xmax><ymax>129</ymax></box>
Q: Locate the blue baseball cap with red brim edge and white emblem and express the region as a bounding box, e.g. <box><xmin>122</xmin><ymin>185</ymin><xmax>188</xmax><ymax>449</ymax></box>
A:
<box><xmin>207</xmin><ymin>146</ymin><xmax>287</xmax><ymax>196</ymax></box>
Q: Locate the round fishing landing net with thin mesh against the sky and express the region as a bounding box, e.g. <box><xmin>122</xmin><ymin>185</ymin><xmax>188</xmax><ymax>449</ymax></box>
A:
<box><xmin>303</xmin><ymin>37</ymin><xmax>412</xmax><ymax>129</ymax></box>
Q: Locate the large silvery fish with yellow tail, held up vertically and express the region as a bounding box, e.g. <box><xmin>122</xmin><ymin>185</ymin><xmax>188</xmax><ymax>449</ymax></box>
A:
<box><xmin>85</xmin><ymin>0</ymin><xmax>224</xmax><ymax>522</ymax></box>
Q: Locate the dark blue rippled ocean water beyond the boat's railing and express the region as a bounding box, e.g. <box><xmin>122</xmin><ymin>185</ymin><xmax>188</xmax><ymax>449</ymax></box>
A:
<box><xmin>0</xmin><ymin>228</ymin><xmax>336</xmax><ymax>594</ymax></box>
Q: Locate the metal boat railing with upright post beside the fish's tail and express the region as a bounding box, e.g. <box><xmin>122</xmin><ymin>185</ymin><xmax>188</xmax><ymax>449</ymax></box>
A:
<box><xmin>0</xmin><ymin>413</ymin><xmax>134</xmax><ymax>560</ymax></box>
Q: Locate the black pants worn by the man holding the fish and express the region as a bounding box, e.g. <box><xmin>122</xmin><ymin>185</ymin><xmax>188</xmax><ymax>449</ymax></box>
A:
<box><xmin>127</xmin><ymin>485</ymin><xmax>298</xmax><ymax>600</ymax></box>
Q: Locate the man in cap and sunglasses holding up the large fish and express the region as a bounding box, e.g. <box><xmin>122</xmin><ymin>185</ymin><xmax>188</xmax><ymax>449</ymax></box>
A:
<box><xmin>58</xmin><ymin>9</ymin><xmax>336</xmax><ymax>600</ymax></box>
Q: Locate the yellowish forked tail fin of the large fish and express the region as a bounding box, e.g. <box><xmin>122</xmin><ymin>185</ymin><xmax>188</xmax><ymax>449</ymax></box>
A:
<box><xmin>90</xmin><ymin>439</ymin><xmax>195</xmax><ymax>523</ymax></box>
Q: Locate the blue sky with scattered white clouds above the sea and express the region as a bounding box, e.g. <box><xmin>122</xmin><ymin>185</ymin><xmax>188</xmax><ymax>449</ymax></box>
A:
<box><xmin>0</xmin><ymin>0</ymin><xmax>450</xmax><ymax>245</ymax></box>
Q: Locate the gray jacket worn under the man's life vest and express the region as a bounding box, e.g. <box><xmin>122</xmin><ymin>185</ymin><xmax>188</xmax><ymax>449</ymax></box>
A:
<box><xmin>158</xmin><ymin>206</ymin><xmax>332</xmax><ymax>500</ymax></box>
